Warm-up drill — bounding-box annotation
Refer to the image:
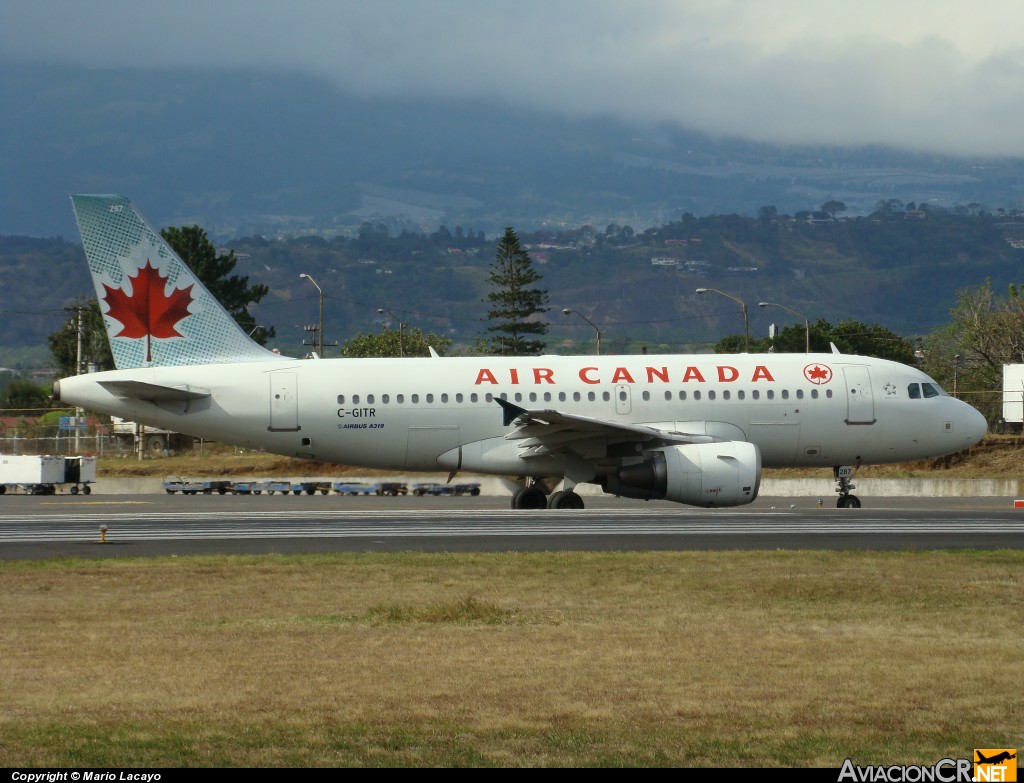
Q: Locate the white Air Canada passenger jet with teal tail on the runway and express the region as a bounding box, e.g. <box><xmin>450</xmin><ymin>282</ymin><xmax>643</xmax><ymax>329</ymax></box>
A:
<box><xmin>54</xmin><ymin>194</ymin><xmax>987</xmax><ymax>510</ymax></box>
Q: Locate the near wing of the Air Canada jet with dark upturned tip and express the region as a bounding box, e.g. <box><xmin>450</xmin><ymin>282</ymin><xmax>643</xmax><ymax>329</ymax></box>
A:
<box><xmin>495</xmin><ymin>398</ymin><xmax>719</xmax><ymax>458</ymax></box>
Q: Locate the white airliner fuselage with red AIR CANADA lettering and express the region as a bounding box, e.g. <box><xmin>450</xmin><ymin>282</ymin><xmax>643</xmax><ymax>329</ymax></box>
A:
<box><xmin>58</xmin><ymin>354</ymin><xmax>985</xmax><ymax>476</ymax></box>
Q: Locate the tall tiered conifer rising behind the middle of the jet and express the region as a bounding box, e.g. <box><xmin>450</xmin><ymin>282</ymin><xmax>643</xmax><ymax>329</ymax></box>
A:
<box><xmin>484</xmin><ymin>226</ymin><xmax>548</xmax><ymax>356</ymax></box>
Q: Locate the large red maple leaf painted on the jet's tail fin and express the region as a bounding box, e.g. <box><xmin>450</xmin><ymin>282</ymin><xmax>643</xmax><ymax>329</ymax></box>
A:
<box><xmin>103</xmin><ymin>259</ymin><xmax>193</xmax><ymax>361</ymax></box>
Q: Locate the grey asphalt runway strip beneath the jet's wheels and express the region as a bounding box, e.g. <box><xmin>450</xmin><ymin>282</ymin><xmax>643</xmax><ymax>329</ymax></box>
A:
<box><xmin>0</xmin><ymin>495</ymin><xmax>1024</xmax><ymax>560</ymax></box>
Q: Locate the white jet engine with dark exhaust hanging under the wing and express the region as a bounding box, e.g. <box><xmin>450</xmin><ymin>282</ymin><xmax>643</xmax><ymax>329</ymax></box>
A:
<box><xmin>603</xmin><ymin>440</ymin><xmax>761</xmax><ymax>508</ymax></box>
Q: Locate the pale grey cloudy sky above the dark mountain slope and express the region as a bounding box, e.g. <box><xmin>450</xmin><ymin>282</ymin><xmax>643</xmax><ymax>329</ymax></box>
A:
<box><xmin>8</xmin><ymin>0</ymin><xmax>1024</xmax><ymax>156</ymax></box>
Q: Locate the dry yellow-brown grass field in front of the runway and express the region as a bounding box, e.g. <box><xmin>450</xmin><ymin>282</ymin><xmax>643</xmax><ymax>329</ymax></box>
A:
<box><xmin>0</xmin><ymin>551</ymin><xmax>1024</xmax><ymax>770</ymax></box>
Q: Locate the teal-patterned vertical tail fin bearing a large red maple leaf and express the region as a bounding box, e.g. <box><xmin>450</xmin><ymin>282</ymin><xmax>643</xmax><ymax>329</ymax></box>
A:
<box><xmin>71</xmin><ymin>195</ymin><xmax>282</xmax><ymax>369</ymax></box>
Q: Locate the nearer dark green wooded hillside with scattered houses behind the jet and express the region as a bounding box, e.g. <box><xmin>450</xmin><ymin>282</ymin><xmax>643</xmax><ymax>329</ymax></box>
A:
<box><xmin>0</xmin><ymin>202</ymin><xmax>1024</xmax><ymax>364</ymax></box>
